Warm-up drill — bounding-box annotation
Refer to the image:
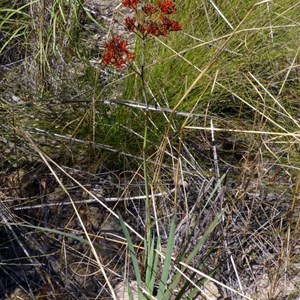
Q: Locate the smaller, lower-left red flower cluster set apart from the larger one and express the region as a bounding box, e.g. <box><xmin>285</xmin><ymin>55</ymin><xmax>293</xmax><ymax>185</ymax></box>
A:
<box><xmin>102</xmin><ymin>35</ymin><xmax>134</xmax><ymax>69</ymax></box>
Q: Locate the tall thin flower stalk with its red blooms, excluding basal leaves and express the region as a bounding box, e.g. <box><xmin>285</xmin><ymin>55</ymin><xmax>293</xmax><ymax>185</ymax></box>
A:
<box><xmin>101</xmin><ymin>0</ymin><xmax>182</xmax><ymax>284</ymax></box>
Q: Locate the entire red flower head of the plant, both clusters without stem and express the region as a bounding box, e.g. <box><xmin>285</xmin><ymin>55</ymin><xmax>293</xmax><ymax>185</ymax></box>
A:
<box><xmin>102</xmin><ymin>0</ymin><xmax>182</xmax><ymax>69</ymax></box>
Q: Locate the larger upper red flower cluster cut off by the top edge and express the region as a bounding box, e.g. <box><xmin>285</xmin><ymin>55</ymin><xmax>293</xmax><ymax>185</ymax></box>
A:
<box><xmin>122</xmin><ymin>0</ymin><xmax>181</xmax><ymax>36</ymax></box>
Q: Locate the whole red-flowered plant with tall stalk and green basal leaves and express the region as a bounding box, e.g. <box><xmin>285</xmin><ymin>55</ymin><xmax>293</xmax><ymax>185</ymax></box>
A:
<box><xmin>102</xmin><ymin>0</ymin><xmax>181</xmax><ymax>299</ymax></box>
